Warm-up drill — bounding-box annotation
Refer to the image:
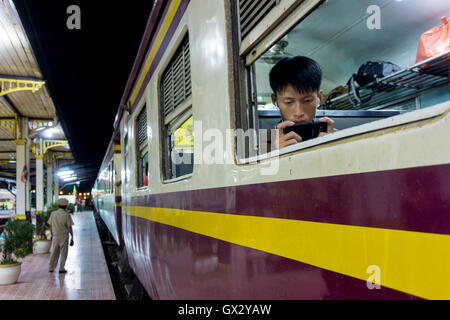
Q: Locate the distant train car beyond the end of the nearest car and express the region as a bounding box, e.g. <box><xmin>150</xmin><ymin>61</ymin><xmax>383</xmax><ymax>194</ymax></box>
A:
<box><xmin>92</xmin><ymin>136</ymin><xmax>123</xmax><ymax>245</ymax></box>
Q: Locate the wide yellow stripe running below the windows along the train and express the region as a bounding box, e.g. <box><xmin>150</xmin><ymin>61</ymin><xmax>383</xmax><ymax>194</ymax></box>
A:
<box><xmin>124</xmin><ymin>206</ymin><xmax>450</xmax><ymax>299</ymax></box>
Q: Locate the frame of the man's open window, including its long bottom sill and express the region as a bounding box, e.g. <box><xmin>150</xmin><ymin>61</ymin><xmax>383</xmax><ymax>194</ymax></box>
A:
<box><xmin>230</xmin><ymin>0</ymin><xmax>448</xmax><ymax>165</ymax></box>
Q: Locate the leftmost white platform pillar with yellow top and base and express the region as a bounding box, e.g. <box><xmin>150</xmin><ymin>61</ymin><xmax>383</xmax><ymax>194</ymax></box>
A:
<box><xmin>14</xmin><ymin>140</ymin><xmax>30</xmax><ymax>220</ymax></box>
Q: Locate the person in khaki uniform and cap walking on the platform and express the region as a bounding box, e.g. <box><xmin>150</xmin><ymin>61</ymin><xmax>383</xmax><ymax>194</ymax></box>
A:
<box><xmin>48</xmin><ymin>199</ymin><xmax>74</xmax><ymax>273</ymax></box>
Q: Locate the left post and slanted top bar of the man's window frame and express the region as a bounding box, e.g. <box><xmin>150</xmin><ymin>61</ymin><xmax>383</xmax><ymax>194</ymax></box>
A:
<box><xmin>230</xmin><ymin>0</ymin><xmax>325</xmax><ymax>163</ymax></box>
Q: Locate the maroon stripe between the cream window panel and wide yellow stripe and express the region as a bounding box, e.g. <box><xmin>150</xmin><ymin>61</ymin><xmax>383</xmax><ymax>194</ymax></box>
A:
<box><xmin>124</xmin><ymin>164</ymin><xmax>450</xmax><ymax>234</ymax></box>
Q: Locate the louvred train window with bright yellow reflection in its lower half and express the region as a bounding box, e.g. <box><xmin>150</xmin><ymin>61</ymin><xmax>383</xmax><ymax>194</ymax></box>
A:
<box><xmin>160</xmin><ymin>34</ymin><xmax>194</xmax><ymax>180</ymax></box>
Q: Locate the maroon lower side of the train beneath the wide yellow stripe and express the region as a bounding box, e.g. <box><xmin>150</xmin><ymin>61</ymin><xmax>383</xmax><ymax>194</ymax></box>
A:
<box><xmin>127</xmin><ymin>216</ymin><xmax>420</xmax><ymax>300</ymax></box>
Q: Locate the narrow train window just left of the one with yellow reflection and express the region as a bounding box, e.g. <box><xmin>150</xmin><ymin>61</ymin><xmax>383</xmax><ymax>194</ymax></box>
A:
<box><xmin>136</xmin><ymin>105</ymin><xmax>148</xmax><ymax>188</ymax></box>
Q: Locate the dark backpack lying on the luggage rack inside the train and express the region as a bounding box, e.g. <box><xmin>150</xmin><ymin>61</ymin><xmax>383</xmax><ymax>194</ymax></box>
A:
<box><xmin>347</xmin><ymin>61</ymin><xmax>402</xmax><ymax>107</ymax></box>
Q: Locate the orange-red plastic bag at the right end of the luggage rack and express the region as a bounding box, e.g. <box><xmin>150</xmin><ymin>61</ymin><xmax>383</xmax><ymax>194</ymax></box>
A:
<box><xmin>416</xmin><ymin>17</ymin><xmax>450</xmax><ymax>63</ymax></box>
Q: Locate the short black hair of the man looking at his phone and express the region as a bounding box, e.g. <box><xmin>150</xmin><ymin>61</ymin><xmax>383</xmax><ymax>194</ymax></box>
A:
<box><xmin>269</xmin><ymin>56</ymin><xmax>322</xmax><ymax>95</ymax></box>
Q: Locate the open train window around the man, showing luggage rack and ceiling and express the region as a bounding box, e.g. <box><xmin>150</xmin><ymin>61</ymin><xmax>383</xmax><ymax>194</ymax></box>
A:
<box><xmin>235</xmin><ymin>0</ymin><xmax>450</xmax><ymax>159</ymax></box>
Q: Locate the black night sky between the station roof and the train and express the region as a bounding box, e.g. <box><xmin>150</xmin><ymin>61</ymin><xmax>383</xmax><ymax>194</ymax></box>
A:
<box><xmin>14</xmin><ymin>0</ymin><xmax>153</xmax><ymax>190</ymax></box>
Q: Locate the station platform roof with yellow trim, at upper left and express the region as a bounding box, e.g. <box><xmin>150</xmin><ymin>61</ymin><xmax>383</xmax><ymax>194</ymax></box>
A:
<box><xmin>0</xmin><ymin>1</ymin><xmax>70</xmax><ymax>184</ymax></box>
